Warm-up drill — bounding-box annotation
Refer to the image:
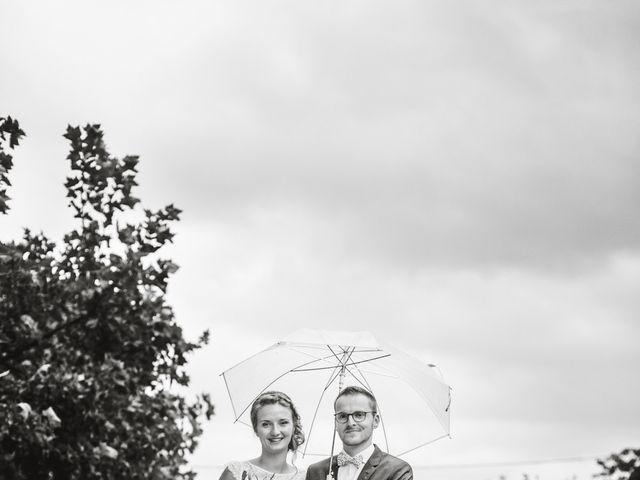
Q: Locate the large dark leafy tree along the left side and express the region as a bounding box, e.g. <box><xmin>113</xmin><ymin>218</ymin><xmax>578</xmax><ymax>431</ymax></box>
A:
<box><xmin>0</xmin><ymin>117</ymin><xmax>213</xmax><ymax>480</ymax></box>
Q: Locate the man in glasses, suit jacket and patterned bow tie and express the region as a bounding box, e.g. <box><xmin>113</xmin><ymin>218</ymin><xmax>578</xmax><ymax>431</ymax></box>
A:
<box><xmin>306</xmin><ymin>386</ymin><xmax>413</xmax><ymax>480</ymax></box>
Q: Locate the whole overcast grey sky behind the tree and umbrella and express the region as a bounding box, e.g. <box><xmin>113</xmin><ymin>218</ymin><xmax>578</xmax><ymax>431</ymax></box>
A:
<box><xmin>0</xmin><ymin>0</ymin><xmax>640</xmax><ymax>479</ymax></box>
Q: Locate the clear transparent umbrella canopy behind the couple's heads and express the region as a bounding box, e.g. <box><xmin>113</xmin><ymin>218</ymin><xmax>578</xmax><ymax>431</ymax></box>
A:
<box><xmin>222</xmin><ymin>330</ymin><xmax>451</xmax><ymax>456</ymax></box>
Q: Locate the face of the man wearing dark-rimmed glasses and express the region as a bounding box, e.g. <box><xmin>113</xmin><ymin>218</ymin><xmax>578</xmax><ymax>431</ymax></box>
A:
<box><xmin>336</xmin><ymin>394</ymin><xmax>380</xmax><ymax>455</ymax></box>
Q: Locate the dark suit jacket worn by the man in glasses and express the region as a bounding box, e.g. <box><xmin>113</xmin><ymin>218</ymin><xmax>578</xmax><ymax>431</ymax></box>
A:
<box><xmin>306</xmin><ymin>445</ymin><xmax>413</xmax><ymax>480</ymax></box>
